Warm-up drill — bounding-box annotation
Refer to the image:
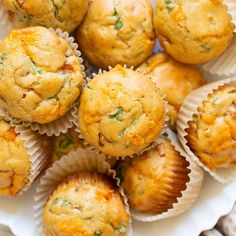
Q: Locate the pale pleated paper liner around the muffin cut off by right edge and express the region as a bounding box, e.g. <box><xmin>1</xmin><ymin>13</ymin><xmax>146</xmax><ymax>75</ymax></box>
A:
<box><xmin>177</xmin><ymin>77</ymin><xmax>236</xmax><ymax>183</ymax></box>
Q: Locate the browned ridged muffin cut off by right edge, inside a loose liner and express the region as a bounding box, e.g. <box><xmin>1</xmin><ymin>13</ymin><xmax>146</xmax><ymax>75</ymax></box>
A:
<box><xmin>186</xmin><ymin>85</ymin><xmax>236</xmax><ymax>171</ymax></box>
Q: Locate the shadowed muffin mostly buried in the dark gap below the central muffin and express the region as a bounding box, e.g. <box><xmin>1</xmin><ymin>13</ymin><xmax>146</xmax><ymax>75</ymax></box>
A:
<box><xmin>50</xmin><ymin>127</ymin><xmax>116</xmax><ymax>167</ymax></box>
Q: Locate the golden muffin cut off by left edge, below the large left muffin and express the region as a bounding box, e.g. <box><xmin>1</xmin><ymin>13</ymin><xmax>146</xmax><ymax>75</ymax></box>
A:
<box><xmin>0</xmin><ymin>118</ymin><xmax>30</xmax><ymax>196</ymax></box>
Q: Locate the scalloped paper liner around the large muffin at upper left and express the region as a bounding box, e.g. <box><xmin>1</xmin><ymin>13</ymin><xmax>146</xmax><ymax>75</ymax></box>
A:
<box><xmin>0</xmin><ymin>28</ymin><xmax>86</xmax><ymax>136</ymax></box>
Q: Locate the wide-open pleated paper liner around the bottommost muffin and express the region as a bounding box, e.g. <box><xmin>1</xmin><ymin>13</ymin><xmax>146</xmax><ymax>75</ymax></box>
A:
<box><xmin>33</xmin><ymin>148</ymin><xmax>132</xmax><ymax>236</ymax></box>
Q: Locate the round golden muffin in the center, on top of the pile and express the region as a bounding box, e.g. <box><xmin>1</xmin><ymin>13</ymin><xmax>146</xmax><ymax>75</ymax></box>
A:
<box><xmin>78</xmin><ymin>65</ymin><xmax>165</xmax><ymax>157</ymax></box>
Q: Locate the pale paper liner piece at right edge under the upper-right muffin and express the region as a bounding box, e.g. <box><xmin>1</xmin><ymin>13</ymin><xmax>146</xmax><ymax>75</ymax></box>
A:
<box><xmin>201</xmin><ymin>35</ymin><xmax>236</xmax><ymax>77</ymax></box>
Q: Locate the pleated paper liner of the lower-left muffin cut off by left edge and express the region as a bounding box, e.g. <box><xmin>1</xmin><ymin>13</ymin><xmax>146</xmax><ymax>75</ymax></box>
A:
<box><xmin>0</xmin><ymin>109</ymin><xmax>50</xmax><ymax>195</ymax></box>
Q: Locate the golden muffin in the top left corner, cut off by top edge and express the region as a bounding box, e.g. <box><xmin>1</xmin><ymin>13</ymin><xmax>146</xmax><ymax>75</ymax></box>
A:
<box><xmin>3</xmin><ymin>0</ymin><xmax>88</xmax><ymax>32</ymax></box>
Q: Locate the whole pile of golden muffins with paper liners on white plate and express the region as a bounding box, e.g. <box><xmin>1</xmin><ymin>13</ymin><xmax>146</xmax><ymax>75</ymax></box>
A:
<box><xmin>0</xmin><ymin>0</ymin><xmax>236</xmax><ymax>236</ymax></box>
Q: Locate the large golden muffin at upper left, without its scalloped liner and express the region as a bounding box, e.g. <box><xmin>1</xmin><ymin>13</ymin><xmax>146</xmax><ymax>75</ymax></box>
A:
<box><xmin>0</xmin><ymin>26</ymin><xmax>83</xmax><ymax>124</ymax></box>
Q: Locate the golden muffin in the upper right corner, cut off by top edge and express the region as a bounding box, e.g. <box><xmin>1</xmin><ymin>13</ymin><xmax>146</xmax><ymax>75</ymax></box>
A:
<box><xmin>154</xmin><ymin>0</ymin><xmax>234</xmax><ymax>64</ymax></box>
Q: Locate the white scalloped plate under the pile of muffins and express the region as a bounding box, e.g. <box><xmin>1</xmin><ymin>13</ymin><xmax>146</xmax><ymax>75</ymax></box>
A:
<box><xmin>0</xmin><ymin>0</ymin><xmax>236</xmax><ymax>236</ymax></box>
